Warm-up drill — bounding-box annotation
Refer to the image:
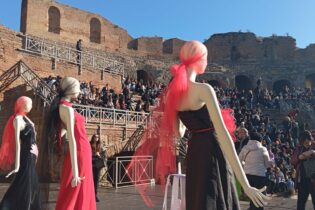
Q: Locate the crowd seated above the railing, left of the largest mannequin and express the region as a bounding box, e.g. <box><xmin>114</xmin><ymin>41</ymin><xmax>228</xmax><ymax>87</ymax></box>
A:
<box><xmin>44</xmin><ymin>76</ymin><xmax>165</xmax><ymax>113</ymax></box>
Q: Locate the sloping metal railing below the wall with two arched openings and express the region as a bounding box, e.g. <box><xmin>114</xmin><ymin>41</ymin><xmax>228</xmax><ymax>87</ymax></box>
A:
<box><xmin>22</xmin><ymin>35</ymin><xmax>124</xmax><ymax>75</ymax></box>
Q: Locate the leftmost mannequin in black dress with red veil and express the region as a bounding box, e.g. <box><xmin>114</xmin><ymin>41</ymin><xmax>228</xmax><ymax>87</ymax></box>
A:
<box><xmin>0</xmin><ymin>96</ymin><xmax>41</xmax><ymax>210</ymax></box>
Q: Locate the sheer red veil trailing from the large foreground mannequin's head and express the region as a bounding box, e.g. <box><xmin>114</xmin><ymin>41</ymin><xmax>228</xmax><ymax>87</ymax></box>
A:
<box><xmin>128</xmin><ymin>48</ymin><xmax>236</xmax><ymax>207</ymax></box>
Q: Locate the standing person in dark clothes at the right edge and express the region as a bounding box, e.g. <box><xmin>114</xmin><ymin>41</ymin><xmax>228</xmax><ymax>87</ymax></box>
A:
<box><xmin>291</xmin><ymin>130</ymin><xmax>315</xmax><ymax>210</ymax></box>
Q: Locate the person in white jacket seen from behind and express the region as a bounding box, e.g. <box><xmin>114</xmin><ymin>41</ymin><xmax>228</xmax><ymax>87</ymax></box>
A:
<box><xmin>239</xmin><ymin>132</ymin><xmax>274</xmax><ymax>210</ymax></box>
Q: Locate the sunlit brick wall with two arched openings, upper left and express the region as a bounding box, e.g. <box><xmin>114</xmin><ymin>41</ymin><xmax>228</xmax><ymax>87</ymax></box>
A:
<box><xmin>21</xmin><ymin>0</ymin><xmax>132</xmax><ymax>50</ymax></box>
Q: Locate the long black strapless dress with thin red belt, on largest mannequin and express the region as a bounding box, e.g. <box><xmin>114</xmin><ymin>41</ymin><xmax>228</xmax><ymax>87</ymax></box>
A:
<box><xmin>178</xmin><ymin>106</ymin><xmax>240</xmax><ymax>210</ymax></box>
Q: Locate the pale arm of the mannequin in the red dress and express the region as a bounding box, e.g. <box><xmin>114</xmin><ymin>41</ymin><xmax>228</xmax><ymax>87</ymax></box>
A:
<box><xmin>59</xmin><ymin>105</ymin><xmax>81</xmax><ymax>187</ymax></box>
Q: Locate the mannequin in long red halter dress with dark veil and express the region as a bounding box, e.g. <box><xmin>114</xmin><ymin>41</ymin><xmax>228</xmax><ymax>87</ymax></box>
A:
<box><xmin>52</xmin><ymin>77</ymin><xmax>96</xmax><ymax>210</ymax></box>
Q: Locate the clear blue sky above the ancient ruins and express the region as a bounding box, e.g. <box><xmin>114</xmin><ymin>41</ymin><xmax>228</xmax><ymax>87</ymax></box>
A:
<box><xmin>0</xmin><ymin>0</ymin><xmax>315</xmax><ymax>48</ymax></box>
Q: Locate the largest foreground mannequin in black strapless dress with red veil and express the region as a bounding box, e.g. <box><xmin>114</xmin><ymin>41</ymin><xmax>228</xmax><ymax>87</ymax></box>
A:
<box><xmin>136</xmin><ymin>41</ymin><xmax>267</xmax><ymax>210</ymax></box>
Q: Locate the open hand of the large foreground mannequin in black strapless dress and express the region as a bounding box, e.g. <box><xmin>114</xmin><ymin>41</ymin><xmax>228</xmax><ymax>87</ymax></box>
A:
<box><xmin>244</xmin><ymin>186</ymin><xmax>270</xmax><ymax>208</ymax></box>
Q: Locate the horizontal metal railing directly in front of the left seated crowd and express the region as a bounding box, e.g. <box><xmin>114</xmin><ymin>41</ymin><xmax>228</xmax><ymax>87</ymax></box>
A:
<box><xmin>73</xmin><ymin>104</ymin><xmax>149</xmax><ymax>127</ymax></box>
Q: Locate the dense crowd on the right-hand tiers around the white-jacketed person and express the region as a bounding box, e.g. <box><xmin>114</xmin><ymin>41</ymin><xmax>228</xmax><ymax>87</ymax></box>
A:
<box><xmin>211</xmin><ymin>80</ymin><xmax>315</xmax><ymax>202</ymax></box>
